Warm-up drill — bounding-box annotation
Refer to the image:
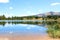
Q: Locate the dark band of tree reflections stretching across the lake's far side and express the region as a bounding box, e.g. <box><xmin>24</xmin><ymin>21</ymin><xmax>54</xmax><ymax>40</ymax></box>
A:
<box><xmin>0</xmin><ymin>21</ymin><xmax>60</xmax><ymax>26</ymax></box>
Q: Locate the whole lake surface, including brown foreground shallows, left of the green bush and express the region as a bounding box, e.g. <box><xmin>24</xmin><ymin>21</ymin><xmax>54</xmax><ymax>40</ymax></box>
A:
<box><xmin>0</xmin><ymin>21</ymin><xmax>47</xmax><ymax>40</ymax></box>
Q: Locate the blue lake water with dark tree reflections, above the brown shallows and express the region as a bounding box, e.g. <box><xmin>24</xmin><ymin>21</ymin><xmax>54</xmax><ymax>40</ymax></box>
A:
<box><xmin>0</xmin><ymin>21</ymin><xmax>47</xmax><ymax>36</ymax></box>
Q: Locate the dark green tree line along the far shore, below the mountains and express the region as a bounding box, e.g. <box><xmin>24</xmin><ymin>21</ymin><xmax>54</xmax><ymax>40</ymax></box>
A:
<box><xmin>0</xmin><ymin>15</ymin><xmax>60</xmax><ymax>20</ymax></box>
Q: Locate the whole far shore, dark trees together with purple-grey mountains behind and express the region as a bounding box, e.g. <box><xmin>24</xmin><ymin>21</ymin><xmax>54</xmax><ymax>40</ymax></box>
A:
<box><xmin>0</xmin><ymin>12</ymin><xmax>60</xmax><ymax>20</ymax></box>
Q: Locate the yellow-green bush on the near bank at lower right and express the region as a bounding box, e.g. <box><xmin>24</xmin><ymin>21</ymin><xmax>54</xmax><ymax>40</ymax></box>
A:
<box><xmin>47</xmin><ymin>24</ymin><xmax>60</xmax><ymax>38</ymax></box>
